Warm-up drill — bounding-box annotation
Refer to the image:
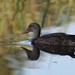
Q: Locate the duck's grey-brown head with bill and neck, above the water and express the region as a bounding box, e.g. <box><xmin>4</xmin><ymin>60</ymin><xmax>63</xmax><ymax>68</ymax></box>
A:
<box><xmin>22</xmin><ymin>23</ymin><xmax>41</xmax><ymax>38</ymax></box>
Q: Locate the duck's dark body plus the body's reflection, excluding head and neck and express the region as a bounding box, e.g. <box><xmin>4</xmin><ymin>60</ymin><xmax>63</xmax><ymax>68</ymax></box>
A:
<box><xmin>32</xmin><ymin>33</ymin><xmax>75</xmax><ymax>55</ymax></box>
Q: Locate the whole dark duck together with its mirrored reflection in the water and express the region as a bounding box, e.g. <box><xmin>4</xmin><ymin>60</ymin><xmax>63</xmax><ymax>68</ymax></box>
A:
<box><xmin>22</xmin><ymin>23</ymin><xmax>75</xmax><ymax>60</ymax></box>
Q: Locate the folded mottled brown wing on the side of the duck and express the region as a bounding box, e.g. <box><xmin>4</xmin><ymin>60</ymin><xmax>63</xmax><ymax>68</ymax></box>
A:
<box><xmin>34</xmin><ymin>33</ymin><xmax>66</xmax><ymax>45</ymax></box>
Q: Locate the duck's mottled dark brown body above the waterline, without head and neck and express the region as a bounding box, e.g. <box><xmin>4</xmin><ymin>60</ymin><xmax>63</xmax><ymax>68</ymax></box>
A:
<box><xmin>34</xmin><ymin>33</ymin><xmax>75</xmax><ymax>46</ymax></box>
